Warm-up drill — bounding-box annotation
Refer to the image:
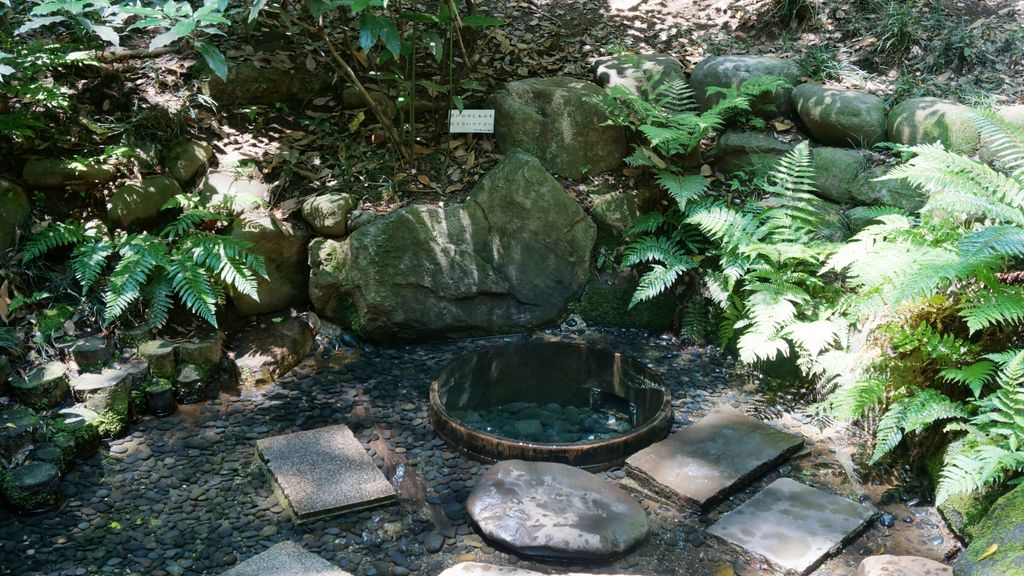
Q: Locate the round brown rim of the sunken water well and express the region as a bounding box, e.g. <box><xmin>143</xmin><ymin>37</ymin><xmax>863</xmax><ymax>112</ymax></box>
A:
<box><xmin>429</xmin><ymin>341</ymin><xmax>673</xmax><ymax>471</ymax></box>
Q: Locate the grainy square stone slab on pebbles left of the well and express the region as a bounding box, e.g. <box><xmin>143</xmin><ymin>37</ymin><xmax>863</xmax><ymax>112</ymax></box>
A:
<box><xmin>256</xmin><ymin>424</ymin><xmax>395</xmax><ymax>523</ymax></box>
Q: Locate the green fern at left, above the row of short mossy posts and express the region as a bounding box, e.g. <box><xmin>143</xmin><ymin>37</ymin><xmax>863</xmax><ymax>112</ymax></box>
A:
<box><xmin>23</xmin><ymin>196</ymin><xmax>266</xmax><ymax>329</ymax></box>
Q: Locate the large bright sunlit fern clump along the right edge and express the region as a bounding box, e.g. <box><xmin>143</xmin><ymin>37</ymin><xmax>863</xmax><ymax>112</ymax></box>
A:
<box><xmin>822</xmin><ymin>114</ymin><xmax>1024</xmax><ymax>502</ymax></box>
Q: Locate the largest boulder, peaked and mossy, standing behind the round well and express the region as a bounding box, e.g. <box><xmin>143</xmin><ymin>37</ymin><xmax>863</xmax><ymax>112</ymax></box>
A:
<box><xmin>309</xmin><ymin>153</ymin><xmax>596</xmax><ymax>339</ymax></box>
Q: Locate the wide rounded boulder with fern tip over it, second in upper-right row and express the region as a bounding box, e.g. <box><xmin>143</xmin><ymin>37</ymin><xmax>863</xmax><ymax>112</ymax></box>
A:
<box><xmin>690</xmin><ymin>55</ymin><xmax>803</xmax><ymax>118</ymax></box>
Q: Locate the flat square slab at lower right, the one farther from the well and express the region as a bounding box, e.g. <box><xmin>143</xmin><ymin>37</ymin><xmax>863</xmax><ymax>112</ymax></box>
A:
<box><xmin>708</xmin><ymin>478</ymin><xmax>874</xmax><ymax>575</ymax></box>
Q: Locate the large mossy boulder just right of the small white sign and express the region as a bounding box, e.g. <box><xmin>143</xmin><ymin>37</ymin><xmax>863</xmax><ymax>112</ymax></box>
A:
<box><xmin>486</xmin><ymin>77</ymin><xmax>626</xmax><ymax>178</ymax></box>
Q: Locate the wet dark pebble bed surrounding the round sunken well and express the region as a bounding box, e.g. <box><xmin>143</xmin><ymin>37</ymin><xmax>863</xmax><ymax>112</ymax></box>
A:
<box><xmin>0</xmin><ymin>331</ymin><xmax>953</xmax><ymax>576</ymax></box>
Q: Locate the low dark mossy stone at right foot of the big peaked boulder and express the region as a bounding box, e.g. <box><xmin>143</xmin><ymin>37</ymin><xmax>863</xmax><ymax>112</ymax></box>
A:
<box><xmin>571</xmin><ymin>273</ymin><xmax>678</xmax><ymax>332</ymax></box>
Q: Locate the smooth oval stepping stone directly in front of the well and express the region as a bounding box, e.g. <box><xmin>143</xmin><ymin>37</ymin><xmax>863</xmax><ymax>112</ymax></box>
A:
<box><xmin>466</xmin><ymin>460</ymin><xmax>650</xmax><ymax>561</ymax></box>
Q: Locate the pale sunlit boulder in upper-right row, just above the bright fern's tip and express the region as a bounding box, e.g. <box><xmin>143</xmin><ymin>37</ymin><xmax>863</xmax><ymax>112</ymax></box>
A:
<box><xmin>887</xmin><ymin>98</ymin><xmax>979</xmax><ymax>154</ymax></box>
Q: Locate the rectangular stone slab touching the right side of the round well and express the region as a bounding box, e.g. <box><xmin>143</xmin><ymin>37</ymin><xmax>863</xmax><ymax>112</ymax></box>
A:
<box><xmin>626</xmin><ymin>406</ymin><xmax>804</xmax><ymax>510</ymax></box>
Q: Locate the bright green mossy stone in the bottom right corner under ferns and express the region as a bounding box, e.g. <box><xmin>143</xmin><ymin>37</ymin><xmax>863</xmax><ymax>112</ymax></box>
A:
<box><xmin>956</xmin><ymin>485</ymin><xmax>1024</xmax><ymax>576</ymax></box>
